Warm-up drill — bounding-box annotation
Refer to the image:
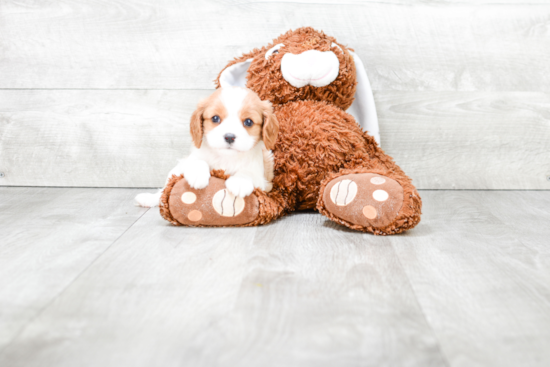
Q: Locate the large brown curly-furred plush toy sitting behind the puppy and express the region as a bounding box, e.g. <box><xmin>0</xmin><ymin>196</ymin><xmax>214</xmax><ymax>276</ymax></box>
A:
<box><xmin>160</xmin><ymin>28</ymin><xmax>422</xmax><ymax>235</ymax></box>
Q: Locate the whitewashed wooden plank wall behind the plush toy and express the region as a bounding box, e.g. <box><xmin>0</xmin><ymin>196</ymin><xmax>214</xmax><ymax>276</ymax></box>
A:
<box><xmin>0</xmin><ymin>0</ymin><xmax>550</xmax><ymax>189</ymax></box>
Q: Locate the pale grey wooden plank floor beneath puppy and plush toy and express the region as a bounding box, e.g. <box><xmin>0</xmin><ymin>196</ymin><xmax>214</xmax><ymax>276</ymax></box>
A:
<box><xmin>0</xmin><ymin>187</ymin><xmax>550</xmax><ymax>367</ymax></box>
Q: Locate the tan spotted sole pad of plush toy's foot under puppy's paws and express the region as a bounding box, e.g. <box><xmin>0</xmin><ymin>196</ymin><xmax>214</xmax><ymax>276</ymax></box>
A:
<box><xmin>168</xmin><ymin>177</ymin><xmax>259</xmax><ymax>227</ymax></box>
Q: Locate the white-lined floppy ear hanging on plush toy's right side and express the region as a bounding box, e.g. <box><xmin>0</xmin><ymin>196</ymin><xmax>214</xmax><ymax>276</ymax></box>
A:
<box><xmin>346</xmin><ymin>51</ymin><xmax>380</xmax><ymax>145</ymax></box>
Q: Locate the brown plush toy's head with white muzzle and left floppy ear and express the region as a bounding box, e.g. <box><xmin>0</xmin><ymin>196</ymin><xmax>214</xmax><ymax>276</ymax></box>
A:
<box><xmin>217</xmin><ymin>27</ymin><xmax>357</xmax><ymax>109</ymax></box>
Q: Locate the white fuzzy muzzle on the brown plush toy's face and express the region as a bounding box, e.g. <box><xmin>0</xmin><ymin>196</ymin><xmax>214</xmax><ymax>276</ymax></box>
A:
<box><xmin>281</xmin><ymin>50</ymin><xmax>340</xmax><ymax>88</ymax></box>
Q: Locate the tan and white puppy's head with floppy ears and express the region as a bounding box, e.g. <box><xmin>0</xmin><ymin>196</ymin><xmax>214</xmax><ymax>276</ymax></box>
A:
<box><xmin>191</xmin><ymin>87</ymin><xmax>279</xmax><ymax>153</ymax></box>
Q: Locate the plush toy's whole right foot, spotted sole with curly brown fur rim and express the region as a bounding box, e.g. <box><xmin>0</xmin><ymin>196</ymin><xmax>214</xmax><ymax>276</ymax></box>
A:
<box><xmin>317</xmin><ymin>166</ymin><xmax>422</xmax><ymax>235</ymax></box>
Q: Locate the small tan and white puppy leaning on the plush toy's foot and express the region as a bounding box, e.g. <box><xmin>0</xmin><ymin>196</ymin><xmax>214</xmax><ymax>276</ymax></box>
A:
<box><xmin>135</xmin><ymin>87</ymin><xmax>279</xmax><ymax>207</ymax></box>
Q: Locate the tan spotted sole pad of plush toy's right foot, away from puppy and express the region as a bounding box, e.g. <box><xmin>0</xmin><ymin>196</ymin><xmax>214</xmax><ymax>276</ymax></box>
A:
<box><xmin>323</xmin><ymin>173</ymin><xmax>403</xmax><ymax>228</ymax></box>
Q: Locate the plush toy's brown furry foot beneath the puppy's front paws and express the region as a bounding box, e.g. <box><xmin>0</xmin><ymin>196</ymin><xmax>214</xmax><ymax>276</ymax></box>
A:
<box><xmin>160</xmin><ymin>171</ymin><xmax>287</xmax><ymax>227</ymax></box>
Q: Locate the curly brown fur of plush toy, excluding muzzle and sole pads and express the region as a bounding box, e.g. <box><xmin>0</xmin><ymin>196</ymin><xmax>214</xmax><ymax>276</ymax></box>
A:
<box><xmin>161</xmin><ymin>28</ymin><xmax>422</xmax><ymax>235</ymax></box>
